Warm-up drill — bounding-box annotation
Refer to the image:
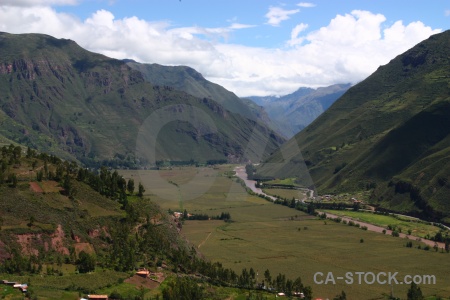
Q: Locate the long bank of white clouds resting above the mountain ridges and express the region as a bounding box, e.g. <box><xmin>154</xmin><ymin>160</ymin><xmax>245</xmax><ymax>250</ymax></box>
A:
<box><xmin>0</xmin><ymin>5</ymin><xmax>441</xmax><ymax>96</ymax></box>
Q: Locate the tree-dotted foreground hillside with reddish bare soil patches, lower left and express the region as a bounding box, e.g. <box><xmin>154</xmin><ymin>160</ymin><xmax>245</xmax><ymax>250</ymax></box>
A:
<box><xmin>0</xmin><ymin>144</ymin><xmax>311</xmax><ymax>299</ymax></box>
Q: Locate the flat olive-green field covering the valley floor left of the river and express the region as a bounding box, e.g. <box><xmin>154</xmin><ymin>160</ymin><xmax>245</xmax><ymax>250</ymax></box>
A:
<box><xmin>122</xmin><ymin>166</ymin><xmax>450</xmax><ymax>299</ymax></box>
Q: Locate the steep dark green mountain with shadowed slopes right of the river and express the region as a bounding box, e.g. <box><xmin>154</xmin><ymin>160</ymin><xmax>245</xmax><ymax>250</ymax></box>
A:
<box><xmin>258</xmin><ymin>31</ymin><xmax>450</xmax><ymax>222</ymax></box>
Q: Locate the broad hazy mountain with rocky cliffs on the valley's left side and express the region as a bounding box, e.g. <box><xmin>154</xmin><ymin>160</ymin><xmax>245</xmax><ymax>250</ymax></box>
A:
<box><xmin>0</xmin><ymin>33</ymin><xmax>284</xmax><ymax>166</ymax></box>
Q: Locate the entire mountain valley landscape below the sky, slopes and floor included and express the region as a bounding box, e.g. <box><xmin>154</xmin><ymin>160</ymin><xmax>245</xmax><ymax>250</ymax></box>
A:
<box><xmin>0</xmin><ymin>27</ymin><xmax>450</xmax><ymax>300</ymax></box>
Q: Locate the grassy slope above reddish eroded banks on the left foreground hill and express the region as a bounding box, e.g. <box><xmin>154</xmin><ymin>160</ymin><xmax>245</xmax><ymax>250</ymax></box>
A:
<box><xmin>0</xmin><ymin>181</ymin><xmax>124</xmax><ymax>238</ymax></box>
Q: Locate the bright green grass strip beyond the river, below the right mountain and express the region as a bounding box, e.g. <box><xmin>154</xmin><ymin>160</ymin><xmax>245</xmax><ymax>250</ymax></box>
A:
<box><xmin>324</xmin><ymin>210</ymin><xmax>440</xmax><ymax>238</ymax></box>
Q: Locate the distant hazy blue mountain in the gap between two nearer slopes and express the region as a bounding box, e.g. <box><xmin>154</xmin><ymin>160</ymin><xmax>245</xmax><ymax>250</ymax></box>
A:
<box><xmin>249</xmin><ymin>84</ymin><xmax>351</xmax><ymax>138</ymax></box>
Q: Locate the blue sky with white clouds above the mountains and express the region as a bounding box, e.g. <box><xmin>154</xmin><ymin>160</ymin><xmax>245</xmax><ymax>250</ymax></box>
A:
<box><xmin>0</xmin><ymin>0</ymin><xmax>450</xmax><ymax>97</ymax></box>
